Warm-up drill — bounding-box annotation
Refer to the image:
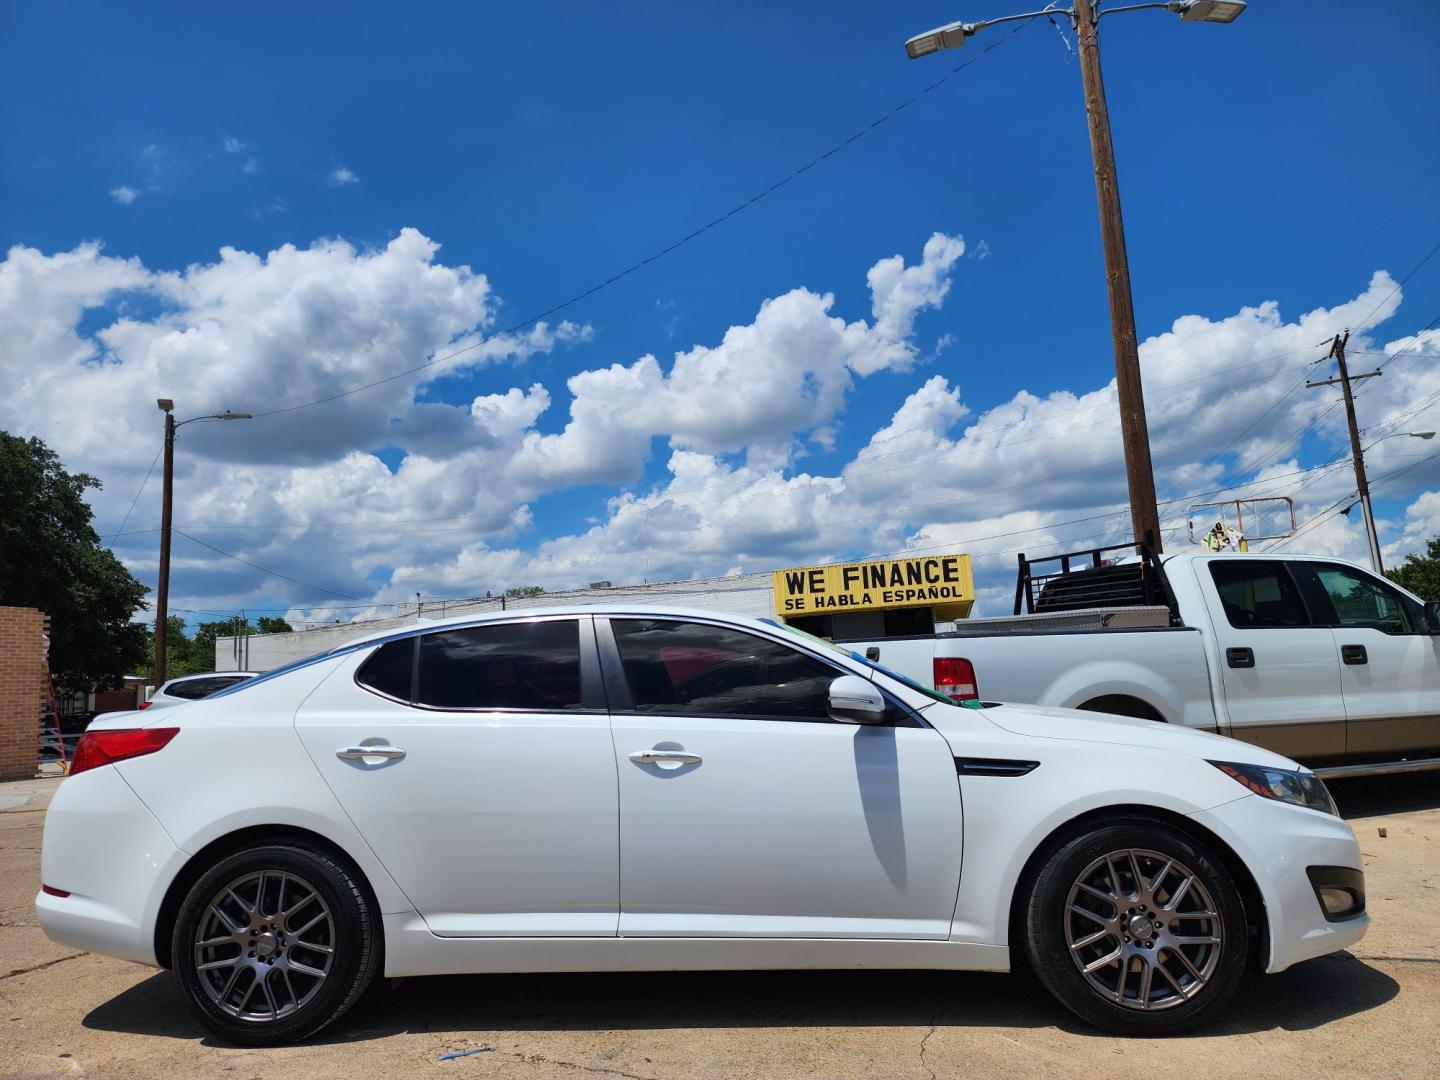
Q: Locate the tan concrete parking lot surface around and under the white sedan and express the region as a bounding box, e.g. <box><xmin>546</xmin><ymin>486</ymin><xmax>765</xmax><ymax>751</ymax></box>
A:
<box><xmin>0</xmin><ymin>775</ymin><xmax>1440</xmax><ymax>1080</ymax></box>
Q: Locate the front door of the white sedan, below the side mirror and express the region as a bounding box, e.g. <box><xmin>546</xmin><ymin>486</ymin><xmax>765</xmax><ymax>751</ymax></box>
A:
<box><xmin>600</xmin><ymin>619</ymin><xmax>962</xmax><ymax>939</ymax></box>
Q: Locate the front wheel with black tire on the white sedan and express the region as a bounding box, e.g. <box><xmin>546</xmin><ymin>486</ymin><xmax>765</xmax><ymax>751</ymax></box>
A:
<box><xmin>1022</xmin><ymin>816</ymin><xmax>1250</xmax><ymax>1035</ymax></box>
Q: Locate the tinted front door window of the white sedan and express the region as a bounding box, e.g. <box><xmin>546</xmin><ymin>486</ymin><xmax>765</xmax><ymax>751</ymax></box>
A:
<box><xmin>611</xmin><ymin>619</ymin><xmax>840</xmax><ymax>720</ymax></box>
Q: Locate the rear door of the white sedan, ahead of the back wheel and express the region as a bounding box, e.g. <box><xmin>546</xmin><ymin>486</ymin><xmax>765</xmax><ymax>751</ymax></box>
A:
<box><xmin>295</xmin><ymin>619</ymin><xmax>619</xmax><ymax>936</ymax></box>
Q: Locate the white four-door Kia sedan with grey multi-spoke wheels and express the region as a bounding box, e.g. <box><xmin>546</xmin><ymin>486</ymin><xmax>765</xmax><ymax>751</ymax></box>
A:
<box><xmin>36</xmin><ymin>608</ymin><xmax>1368</xmax><ymax>1044</ymax></box>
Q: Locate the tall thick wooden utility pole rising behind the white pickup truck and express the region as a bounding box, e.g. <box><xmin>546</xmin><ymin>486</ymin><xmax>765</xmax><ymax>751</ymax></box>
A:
<box><xmin>1074</xmin><ymin>0</ymin><xmax>1161</xmax><ymax>552</ymax></box>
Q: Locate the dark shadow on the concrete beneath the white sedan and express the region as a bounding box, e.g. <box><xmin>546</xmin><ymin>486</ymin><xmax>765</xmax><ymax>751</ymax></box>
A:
<box><xmin>84</xmin><ymin>953</ymin><xmax>1400</xmax><ymax>1044</ymax></box>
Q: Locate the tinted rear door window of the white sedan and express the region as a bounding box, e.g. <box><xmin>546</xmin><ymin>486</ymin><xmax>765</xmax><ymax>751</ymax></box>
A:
<box><xmin>415</xmin><ymin>619</ymin><xmax>580</xmax><ymax>713</ymax></box>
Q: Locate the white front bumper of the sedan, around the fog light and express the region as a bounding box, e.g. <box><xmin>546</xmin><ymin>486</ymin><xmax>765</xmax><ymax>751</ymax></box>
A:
<box><xmin>1191</xmin><ymin>795</ymin><xmax>1369</xmax><ymax>972</ymax></box>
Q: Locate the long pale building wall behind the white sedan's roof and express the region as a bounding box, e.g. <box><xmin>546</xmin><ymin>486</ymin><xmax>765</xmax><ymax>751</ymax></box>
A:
<box><xmin>215</xmin><ymin>573</ymin><xmax>775</xmax><ymax>671</ymax></box>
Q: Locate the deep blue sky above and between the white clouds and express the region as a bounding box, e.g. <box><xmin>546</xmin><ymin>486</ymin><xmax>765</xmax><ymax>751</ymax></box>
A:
<box><xmin>0</xmin><ymin>0</ymin><xmax>1440</xmax><ymax>624</ymax></box>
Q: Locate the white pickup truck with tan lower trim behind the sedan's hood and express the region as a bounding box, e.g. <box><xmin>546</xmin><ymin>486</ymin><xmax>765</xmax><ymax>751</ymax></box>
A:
<box><xmin>838</xmin><ymin>553</ymin><xmax>1440</xmax><ymax>776</ymax></box>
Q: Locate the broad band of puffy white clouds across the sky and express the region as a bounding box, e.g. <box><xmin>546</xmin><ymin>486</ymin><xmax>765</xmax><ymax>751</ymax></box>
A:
<box><xmin>0</xmin><ymin>229</ymin><xmax>1440</xmax><ymax>624</ymax></box>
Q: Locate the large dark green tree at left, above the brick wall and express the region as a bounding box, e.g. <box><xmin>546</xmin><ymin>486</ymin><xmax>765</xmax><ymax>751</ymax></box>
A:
<box><xmin>0</xmin><ymin>432</ymin><xmax>148</xmax><ymax>691</ymax></box>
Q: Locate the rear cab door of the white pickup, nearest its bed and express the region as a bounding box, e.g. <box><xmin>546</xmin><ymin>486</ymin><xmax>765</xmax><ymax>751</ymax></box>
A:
<box><xmin>1195</xmin><ymin>557</ymin><xmax>1345</xmax><ymax>762</ymax></box>
